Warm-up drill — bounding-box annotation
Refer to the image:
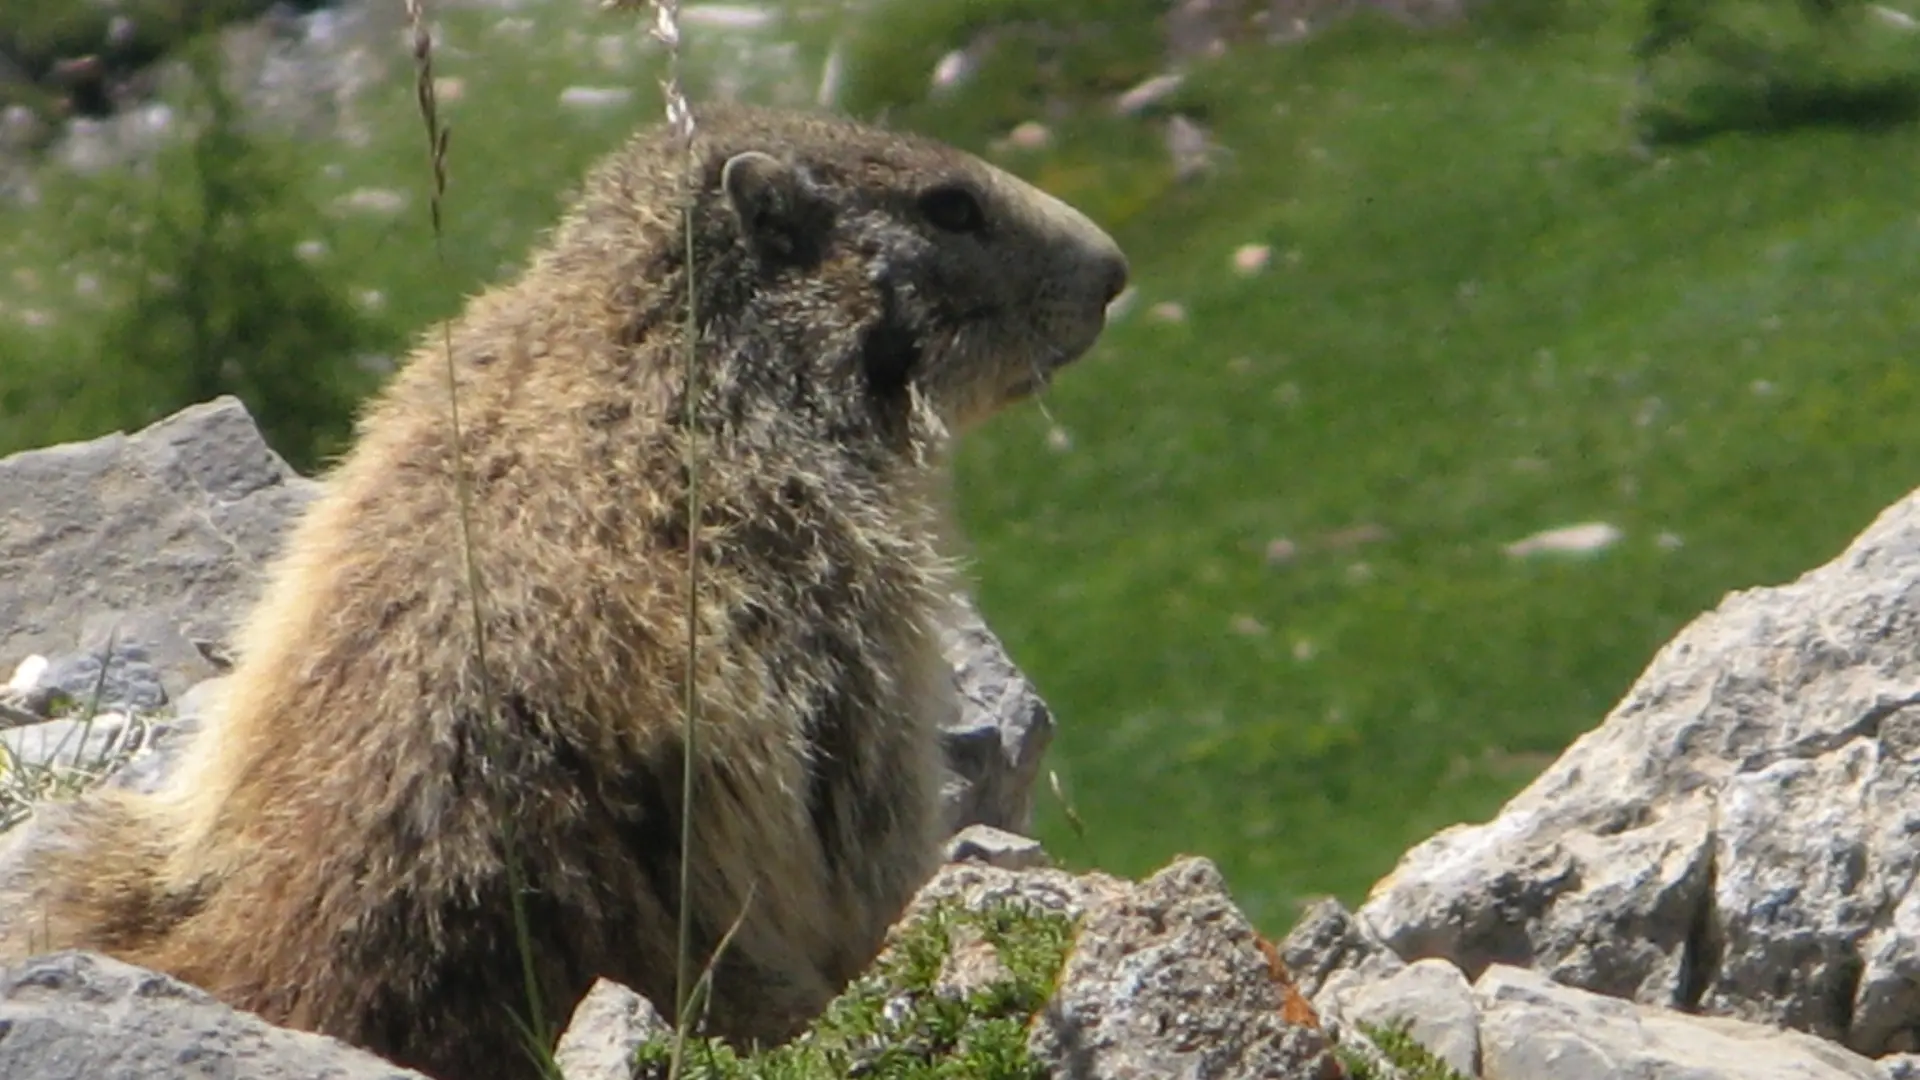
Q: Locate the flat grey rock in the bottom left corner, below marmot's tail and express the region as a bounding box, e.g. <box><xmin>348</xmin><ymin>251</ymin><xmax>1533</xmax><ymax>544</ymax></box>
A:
<box><xmin>0</xmin><ymin>951</ymin><xmax>426</xmax><ymax>1080</ymax></box>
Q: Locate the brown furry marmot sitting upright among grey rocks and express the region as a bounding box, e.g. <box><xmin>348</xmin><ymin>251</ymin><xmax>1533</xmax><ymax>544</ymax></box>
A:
<box><xmin>0</xmin><ymin>106</ymin><xmax>1127</xmax><ymax>1080</ymax></box>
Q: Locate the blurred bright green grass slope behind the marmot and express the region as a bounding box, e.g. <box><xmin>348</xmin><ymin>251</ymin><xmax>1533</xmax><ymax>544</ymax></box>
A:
<box><xmin>0</xmin><ymin>0</ymin><xmax>1920</xmax><ymax>932</ymax></box>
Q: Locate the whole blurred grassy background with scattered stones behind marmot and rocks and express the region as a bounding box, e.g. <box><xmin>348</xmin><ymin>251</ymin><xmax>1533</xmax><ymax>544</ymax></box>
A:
<box><xmin>0</xmin><ymin>0</ymin><xmax>1920</xmax><ymax>932</ymax></box>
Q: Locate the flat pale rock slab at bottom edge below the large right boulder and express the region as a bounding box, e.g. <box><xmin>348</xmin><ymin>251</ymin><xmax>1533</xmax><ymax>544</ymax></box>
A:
<box><xmin>1473</xmin><ymin>965</ymin><xmax>1885</xmax><ymax>1080</ymax></box>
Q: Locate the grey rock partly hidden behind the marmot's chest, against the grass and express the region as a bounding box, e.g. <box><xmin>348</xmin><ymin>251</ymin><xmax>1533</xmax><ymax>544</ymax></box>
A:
<box><xmin>943</xmin><ymin>596</ymin><xmax>1054</xmax><ymax>832</ymax></box>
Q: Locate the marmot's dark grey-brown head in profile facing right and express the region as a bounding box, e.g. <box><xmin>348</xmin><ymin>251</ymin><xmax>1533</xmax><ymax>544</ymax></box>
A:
<box><xmin>557</xmin><ymin>106</ymin><xmax>1127</xmax><ymax>442</ymax></box>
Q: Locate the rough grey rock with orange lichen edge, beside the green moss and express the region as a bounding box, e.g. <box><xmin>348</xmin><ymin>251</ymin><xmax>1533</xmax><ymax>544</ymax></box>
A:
<box><xmin>906</xmin><ymin>857</ymin><xmax>1340</xmax><ymax>1080</ymax></box>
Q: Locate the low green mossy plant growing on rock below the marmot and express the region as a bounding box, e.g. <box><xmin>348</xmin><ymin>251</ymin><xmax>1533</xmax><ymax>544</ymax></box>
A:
<box><xmin>637</xmin><ymin>905</ymin><xmax>1073</xmax><ymax>1080</ymax></box>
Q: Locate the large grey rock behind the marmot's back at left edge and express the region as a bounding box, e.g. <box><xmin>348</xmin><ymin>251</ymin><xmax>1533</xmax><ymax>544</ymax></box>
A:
<box><xmin>0</xmin><ymin>398</ymin><xmax>313</xmax><ymax>696</ymax></box>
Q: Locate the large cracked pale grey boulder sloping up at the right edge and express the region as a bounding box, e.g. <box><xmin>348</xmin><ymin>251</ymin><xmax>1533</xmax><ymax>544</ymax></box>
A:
<box><xmin>1359</xmin><ymin>492</ymin><xmax>1920</xmax><ymax>1055</ymax></box>
